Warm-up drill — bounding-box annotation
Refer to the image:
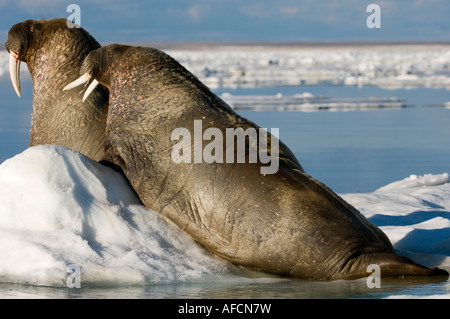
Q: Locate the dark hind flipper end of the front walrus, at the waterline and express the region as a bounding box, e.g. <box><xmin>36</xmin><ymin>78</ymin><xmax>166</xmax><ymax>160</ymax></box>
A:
<box><xmin>344</xmin><ymin>253</ymin><xmax>449</xmax><ymax>279</ymax></box>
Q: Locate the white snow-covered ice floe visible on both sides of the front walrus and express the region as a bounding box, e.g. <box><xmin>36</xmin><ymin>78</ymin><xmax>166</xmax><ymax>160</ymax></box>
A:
<box><xmin>0</xmin><ymin>145</ymin><xmax>450</xmax><ymax>297</ymax></box>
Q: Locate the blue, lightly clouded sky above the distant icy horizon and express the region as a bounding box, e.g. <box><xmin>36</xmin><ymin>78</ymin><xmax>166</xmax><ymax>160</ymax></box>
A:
<box><xmin>0</xmin><ymin>0</ymin><xmax>450</xmax><ymax>43</ymax></box>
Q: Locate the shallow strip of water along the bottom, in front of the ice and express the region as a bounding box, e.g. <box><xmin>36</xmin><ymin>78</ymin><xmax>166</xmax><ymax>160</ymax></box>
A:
<box><xmin>0</xmin><ymin>278</ymin><xmax>450</xmax><ymax>299</ymax></box>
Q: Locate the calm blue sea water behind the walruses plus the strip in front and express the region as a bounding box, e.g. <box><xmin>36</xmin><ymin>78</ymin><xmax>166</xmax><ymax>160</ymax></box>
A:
<box><xmin>0</xmin><ymin>77</ymin><xmax>450</xmax><ymax>298</ymax></box>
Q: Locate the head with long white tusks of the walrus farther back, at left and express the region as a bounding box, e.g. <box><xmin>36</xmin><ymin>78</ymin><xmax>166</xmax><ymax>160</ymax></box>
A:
<box><xmin>5</xmin><ymin>19</ymin><xmax>100</xmax><ymax>97</ymax></box>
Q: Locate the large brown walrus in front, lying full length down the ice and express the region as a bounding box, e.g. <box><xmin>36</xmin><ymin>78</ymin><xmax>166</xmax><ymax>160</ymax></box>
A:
<box><xmin>68</xmin><ymin>44</ymin><xmax>448</xmax><ymax>280</ymax></box>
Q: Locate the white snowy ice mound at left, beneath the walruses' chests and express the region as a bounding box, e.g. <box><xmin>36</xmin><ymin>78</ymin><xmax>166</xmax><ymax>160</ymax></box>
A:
<box><xmin>0</xmin><ymin>146</ymin><xmax>232</xmax><ymax>286</ymax></box>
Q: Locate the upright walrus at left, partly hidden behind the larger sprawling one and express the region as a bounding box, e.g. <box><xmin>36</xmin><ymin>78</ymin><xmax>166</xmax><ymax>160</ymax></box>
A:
<box><xmin>5</xmin><ymin>19</ymin><xmax>108</xmax><ymax>161</ymax></box>
